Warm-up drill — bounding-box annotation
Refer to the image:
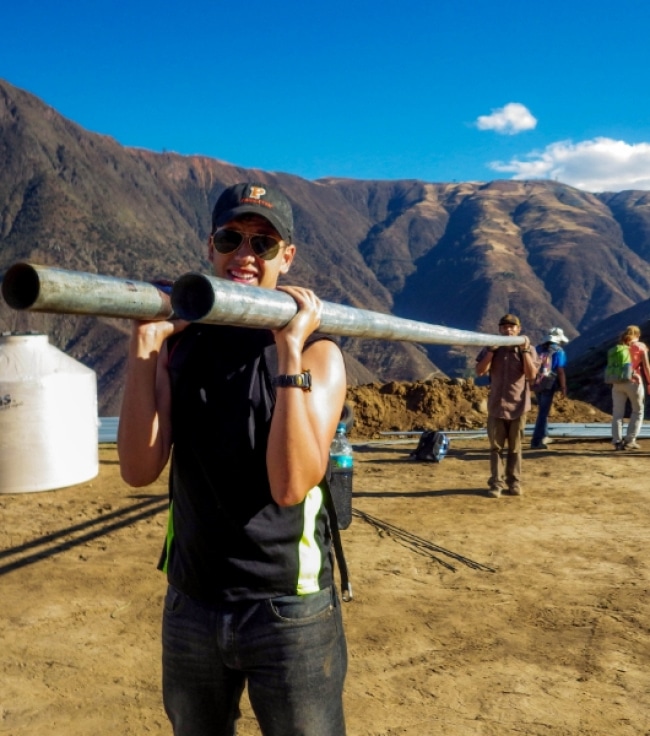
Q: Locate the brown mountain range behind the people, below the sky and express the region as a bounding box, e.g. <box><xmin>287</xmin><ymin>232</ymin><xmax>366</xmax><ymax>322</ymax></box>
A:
<box><xmin>0</xmin><ymin>80</ymin><xmax>650</xmax><ymax>415</ymax></box>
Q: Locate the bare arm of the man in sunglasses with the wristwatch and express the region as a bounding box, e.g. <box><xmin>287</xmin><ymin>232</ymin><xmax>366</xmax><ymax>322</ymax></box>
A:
<box><xmin>266</xmin><ymin>287</ymin><xmax>347</xmax><ymax>506</ymax></box>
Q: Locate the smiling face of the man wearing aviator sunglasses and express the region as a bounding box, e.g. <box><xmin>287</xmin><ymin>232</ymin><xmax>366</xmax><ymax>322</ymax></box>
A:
<box><xmin>208</xmin><ymin>215</ymin><xmax>296</xmax><ymax>289</ymax></box>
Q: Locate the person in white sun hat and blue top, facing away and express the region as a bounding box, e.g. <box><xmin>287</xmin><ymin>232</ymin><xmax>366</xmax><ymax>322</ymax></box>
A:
<box><xmin>530</xmin><ymin>327</ymin><xmax>569</xmax><ymax>450</ymax></box>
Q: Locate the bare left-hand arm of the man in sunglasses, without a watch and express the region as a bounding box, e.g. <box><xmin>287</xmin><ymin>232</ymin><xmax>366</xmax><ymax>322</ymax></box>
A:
<box><xmin>117</xmin><ymin>321</ymin><xmax>187</xmax><ymax>487</ymax></box>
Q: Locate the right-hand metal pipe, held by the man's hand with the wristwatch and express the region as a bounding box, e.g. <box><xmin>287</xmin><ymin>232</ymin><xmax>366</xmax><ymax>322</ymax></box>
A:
<box><xmin>171</xmin><ymin>273</ymin><xmax>524</xmax><ymax>346</ymax></box>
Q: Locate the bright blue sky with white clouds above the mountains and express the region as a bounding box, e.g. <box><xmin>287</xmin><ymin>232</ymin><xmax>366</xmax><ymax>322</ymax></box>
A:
<box><xmin>0</xmin><ymin>0</ymin><xmax>650</xmax><ymax>191</ymax></box>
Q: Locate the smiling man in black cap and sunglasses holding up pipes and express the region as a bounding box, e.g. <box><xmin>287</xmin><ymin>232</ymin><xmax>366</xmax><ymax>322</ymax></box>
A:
<box><xmin>118</xmin><ymin>183</ymin><xmax>347</xmax><ymax>736</ymax></box>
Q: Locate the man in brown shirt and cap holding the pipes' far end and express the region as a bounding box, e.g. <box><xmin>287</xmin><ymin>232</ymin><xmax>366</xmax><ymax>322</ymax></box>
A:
<box><xmin>476</xmin><ymin>314</ymin><xmax>539</xmax><ymax>498</ymax></box>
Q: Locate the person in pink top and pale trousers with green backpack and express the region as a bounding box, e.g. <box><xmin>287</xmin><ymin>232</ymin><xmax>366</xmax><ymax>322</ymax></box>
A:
<box><xmin>605</xmin><ymin>325</ymin><xmax>650</xmax><ymax>450</ymax></box>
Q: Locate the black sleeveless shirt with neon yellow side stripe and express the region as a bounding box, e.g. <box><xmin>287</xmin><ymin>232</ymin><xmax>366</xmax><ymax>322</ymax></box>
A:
<box><xmin>161</xmin><ymin>324</ymin><xmax>332</xmax><ymax>603</ymax></box>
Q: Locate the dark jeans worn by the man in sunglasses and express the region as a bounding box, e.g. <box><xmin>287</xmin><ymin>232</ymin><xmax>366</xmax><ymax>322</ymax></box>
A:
<box><xmin>162</xmin><ymin>586</ymin><xmax>347</xmax><ymax>736</ymax></box>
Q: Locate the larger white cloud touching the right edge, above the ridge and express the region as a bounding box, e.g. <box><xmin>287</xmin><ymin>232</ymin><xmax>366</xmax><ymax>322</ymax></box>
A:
<box><xmin>489</xmin><ymin>138</ymin><xmax>650</xmax><ymax>192</ymax></box>
